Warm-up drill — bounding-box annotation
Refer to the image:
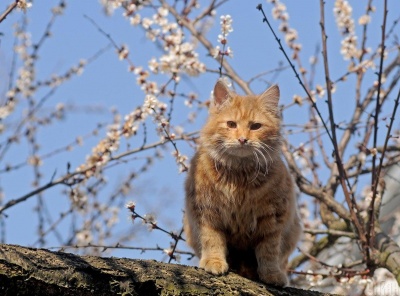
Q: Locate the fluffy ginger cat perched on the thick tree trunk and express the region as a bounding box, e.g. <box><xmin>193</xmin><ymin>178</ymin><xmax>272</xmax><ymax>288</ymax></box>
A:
<box><xmin>184</xmin><ymin>80</ymin><xmax>301</xmax><ymax>286</ymax></box>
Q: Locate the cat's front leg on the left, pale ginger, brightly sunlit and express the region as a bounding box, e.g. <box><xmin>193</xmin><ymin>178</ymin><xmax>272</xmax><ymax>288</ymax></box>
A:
<box><xmin>199</xmin><ymin>226</ymin><xmax>228</xmax><ymax>275</ymax></box>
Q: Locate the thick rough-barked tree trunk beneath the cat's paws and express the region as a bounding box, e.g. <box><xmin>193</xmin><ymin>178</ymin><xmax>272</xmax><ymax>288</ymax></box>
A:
<box><xmin>0</xmin><ymin>245</ymin><xmax>334</xmax><ymax>296</ymax></box>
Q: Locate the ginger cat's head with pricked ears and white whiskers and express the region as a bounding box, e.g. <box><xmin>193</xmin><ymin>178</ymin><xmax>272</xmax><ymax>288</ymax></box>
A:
<box><xmin>202</xmin><ymin>80</ymin><xmax>281</xmax><ymax>163</ymax></box>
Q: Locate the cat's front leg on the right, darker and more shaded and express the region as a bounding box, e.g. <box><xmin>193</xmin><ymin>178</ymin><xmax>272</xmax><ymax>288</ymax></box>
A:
<box><xmin>255</xmin><ymin>233</ymin><xmax>288</xmax><ymax>287</ymax></box>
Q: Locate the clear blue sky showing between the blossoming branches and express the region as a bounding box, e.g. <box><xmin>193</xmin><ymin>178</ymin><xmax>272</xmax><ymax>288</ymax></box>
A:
<box><xmin>0</xmin><ymin>0</ymin><xmax>400</xmax><ymax>259</ymax></box>
